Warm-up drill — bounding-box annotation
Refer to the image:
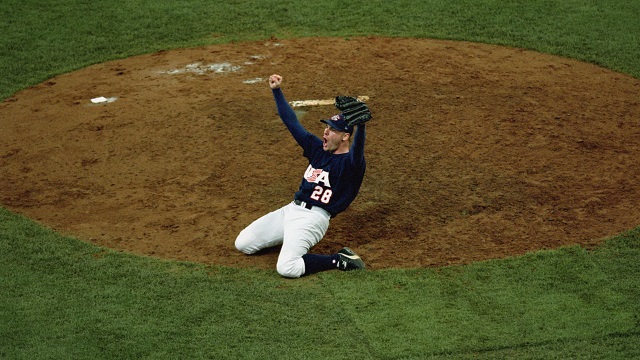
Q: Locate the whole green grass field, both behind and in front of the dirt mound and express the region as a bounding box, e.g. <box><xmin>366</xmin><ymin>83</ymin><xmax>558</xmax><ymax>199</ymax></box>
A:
<box><xmin>0</xmin><ymin>0</ymin><xmax>640</xmax><ymax>359</ymax></box>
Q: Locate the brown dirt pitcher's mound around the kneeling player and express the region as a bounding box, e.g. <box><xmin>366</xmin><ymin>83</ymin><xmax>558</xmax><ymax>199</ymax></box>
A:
<box><xmin>0</xmin><ymin>38</ymin><xmax>640</xmax><ymax>269</ymax></box>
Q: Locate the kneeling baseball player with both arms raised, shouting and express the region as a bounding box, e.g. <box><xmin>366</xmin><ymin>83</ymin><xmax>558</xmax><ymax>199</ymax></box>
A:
<box><xmin>235</xmin><ymin>75</ymin><xmax>371</xmax><ymax>278</ymax></box>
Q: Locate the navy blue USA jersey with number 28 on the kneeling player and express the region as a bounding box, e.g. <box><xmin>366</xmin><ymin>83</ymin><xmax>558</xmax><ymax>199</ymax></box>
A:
<box><xmin>273</xmin><ymin>89</ymin><xmax>366</xmax><ymax>217</ymax></box>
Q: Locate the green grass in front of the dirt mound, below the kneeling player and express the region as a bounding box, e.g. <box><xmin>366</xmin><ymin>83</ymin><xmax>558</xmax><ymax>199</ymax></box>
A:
<box><xmin>0</xmin><ymin>209</ymin><xmax>640</xmax><ymax>359</ymax></box>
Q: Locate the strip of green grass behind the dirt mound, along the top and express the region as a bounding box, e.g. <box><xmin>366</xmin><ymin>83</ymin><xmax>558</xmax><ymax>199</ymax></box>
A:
<box><xmin>0</xmin><ymin>0</ymin><xmax>640</xmax><ymax>100</ymax></box>
